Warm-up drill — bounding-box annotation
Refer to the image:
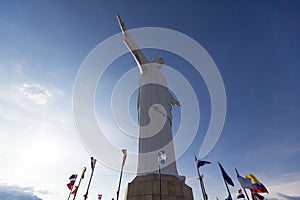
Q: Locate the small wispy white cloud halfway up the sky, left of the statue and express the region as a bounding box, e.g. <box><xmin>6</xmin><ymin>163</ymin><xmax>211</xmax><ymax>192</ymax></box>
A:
<box><xmin>18</xmin><ymin>83</ymin><xmax>53</xmax><ymax>104</ymax></box>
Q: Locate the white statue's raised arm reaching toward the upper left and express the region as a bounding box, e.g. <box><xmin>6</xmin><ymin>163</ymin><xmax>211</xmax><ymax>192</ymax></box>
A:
<box><xmin>117</xmin><ymin>15</ymin><xmax>149</xmax><ymax>74</ymax></box>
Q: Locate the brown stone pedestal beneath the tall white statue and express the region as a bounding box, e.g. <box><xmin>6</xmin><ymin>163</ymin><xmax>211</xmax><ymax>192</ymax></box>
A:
<box><xmin>125</xmin><ymin>174</ymin><xmax>194</xmax><ymax>200</ymax></box>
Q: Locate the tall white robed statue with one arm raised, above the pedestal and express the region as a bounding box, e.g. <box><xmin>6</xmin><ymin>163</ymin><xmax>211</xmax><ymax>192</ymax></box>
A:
<box><xmin>117</xmin><ymin>15</ymin><xmax>180</xmax><ymax>176</ymax></box>
